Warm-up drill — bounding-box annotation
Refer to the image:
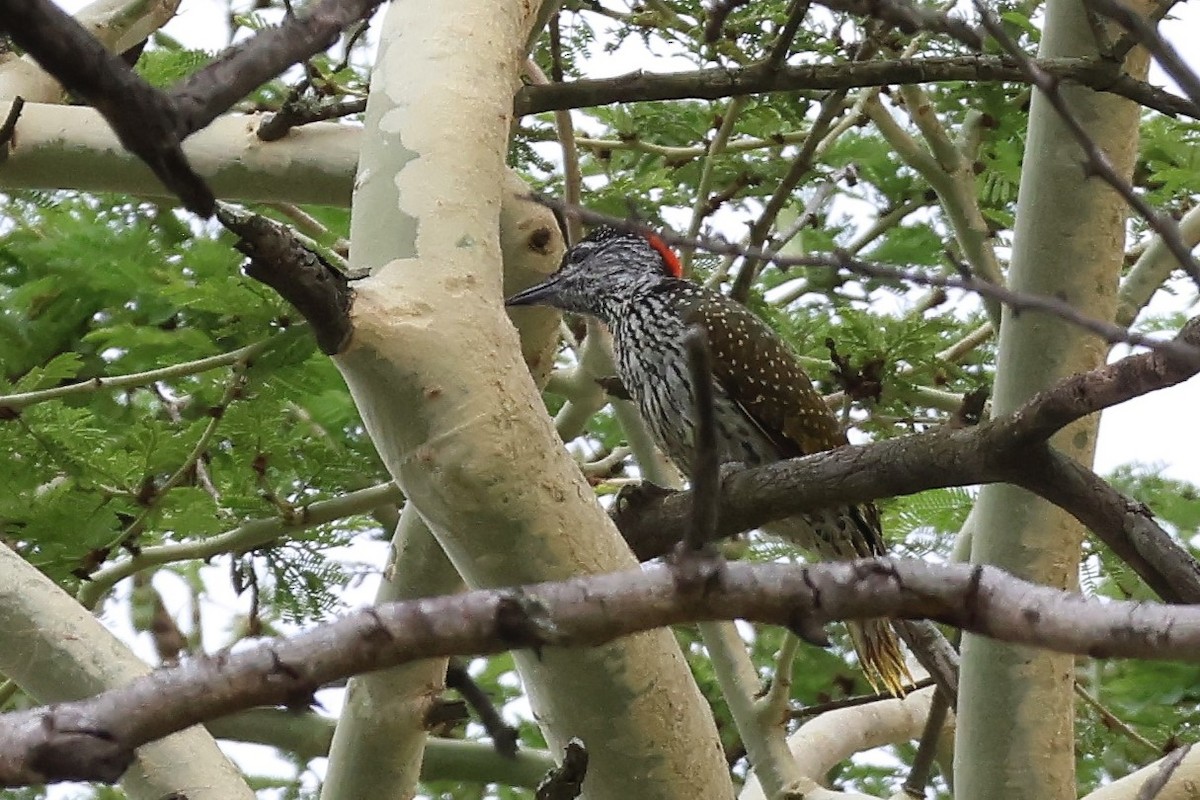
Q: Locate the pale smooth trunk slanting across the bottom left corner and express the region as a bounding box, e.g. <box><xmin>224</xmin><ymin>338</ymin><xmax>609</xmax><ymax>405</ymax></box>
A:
<box><xmin>0</xmin><ymin>545</ymin><xmax>254</xmax><ymax>800</ymax></box>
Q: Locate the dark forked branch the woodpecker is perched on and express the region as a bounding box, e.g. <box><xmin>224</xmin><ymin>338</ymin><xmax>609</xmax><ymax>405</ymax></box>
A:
<box><xmin>612</xmin><ymin>318</ymin><xmax>1200</xmax><ymax>603</ymax></box>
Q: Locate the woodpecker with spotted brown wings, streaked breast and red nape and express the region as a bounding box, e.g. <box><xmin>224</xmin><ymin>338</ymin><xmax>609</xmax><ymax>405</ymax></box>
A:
<box><xmin>506</xmin><ymin>227</ymin><xmax>912</xmax><ymax>697</ymax></box>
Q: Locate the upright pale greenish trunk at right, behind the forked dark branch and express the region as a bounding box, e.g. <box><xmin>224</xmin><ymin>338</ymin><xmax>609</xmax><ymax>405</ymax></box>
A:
<box><xmin>955</xmin><ymin>0</ymin><xmax>1146</xmax><ymax>800</ymax></box>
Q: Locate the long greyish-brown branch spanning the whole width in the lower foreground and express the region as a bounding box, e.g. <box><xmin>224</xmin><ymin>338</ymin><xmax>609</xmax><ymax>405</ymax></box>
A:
<box><xmin>7</xmin><ymin>559</ymin><xmax>1200</xmax><ymax>786</ymax></box>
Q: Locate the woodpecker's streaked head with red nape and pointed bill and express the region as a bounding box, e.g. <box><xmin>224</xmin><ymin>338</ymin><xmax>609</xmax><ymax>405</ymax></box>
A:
<box><xmin>505</xmin><ymin>227</ymin><xmax>683</xmax><ymax>323</ymax></box>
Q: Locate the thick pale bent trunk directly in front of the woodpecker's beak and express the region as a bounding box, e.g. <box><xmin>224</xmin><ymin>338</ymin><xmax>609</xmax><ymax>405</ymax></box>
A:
<box><xmin>336</xmin><ymin>0</ymin><xmax>732</xmax><ymax>800</ymax></box>
